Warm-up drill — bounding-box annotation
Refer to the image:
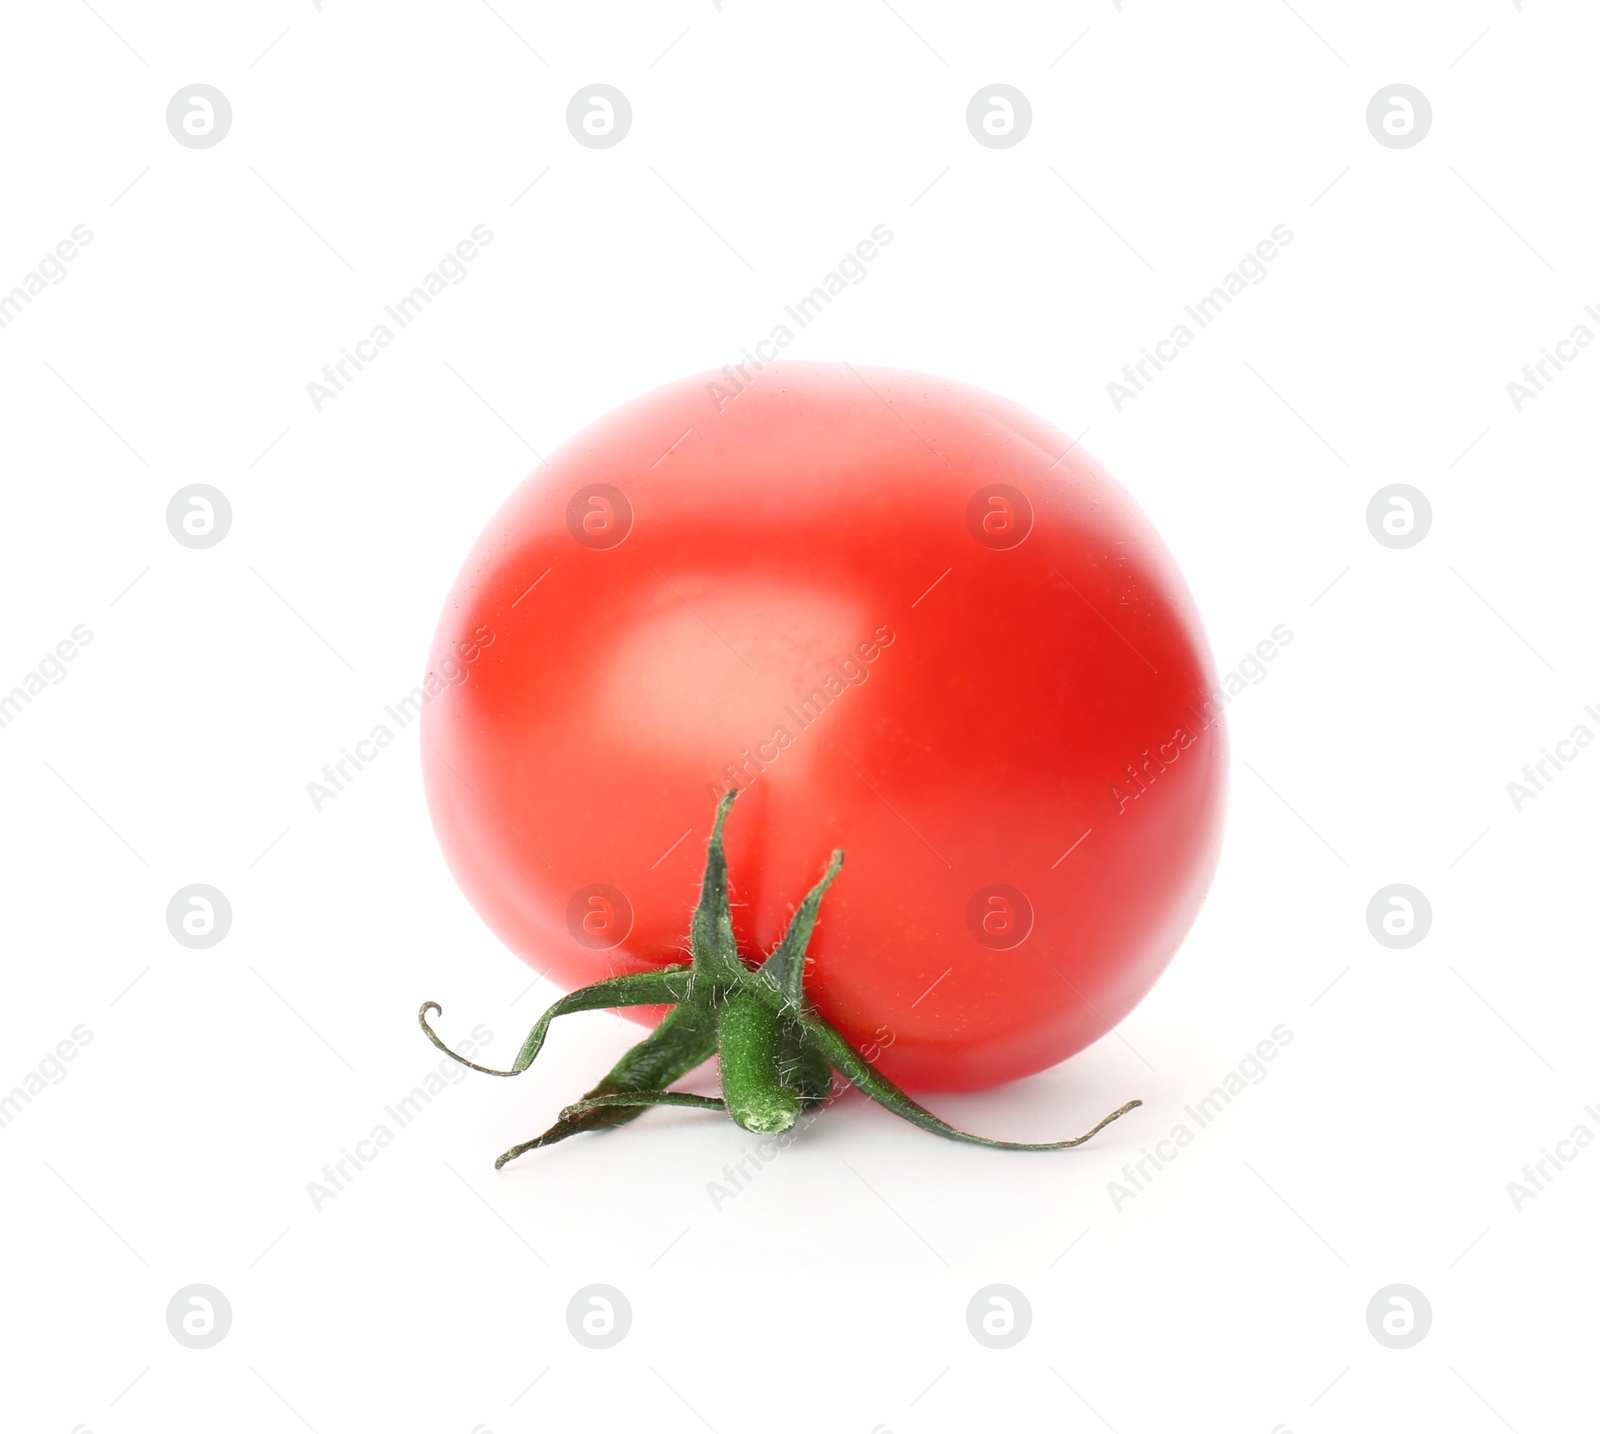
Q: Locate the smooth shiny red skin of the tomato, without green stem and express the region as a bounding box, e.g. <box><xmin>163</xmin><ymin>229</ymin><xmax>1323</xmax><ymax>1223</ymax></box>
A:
<box><xmin>422</xmin><ymin>363</ymin><xmax>1227</xmax><ymax>1090</ymax></box>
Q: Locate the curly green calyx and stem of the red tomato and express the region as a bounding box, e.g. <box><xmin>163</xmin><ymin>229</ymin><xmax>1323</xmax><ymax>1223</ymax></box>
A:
<box><xmin>418</xmin><ymin>789</ymin><xmax>1142</xmax><ymax>1170</ymax></box>
